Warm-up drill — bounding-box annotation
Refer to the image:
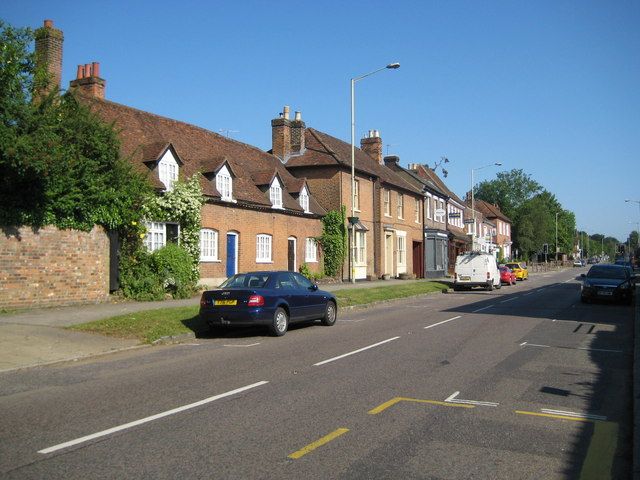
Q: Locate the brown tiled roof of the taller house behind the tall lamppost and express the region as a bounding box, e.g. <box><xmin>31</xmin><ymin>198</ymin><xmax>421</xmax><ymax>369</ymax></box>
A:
<box><xmin>286</xmin><ymin>128</ymin><xmax>421</xmax><ymax>194</ymax></box>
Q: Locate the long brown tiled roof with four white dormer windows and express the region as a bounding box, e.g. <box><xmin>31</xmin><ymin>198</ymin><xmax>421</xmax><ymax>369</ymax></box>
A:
<box><xmin>80</xmin><ymin>97</ymin><xmax>326</xmax><ymax>215</ymax></box>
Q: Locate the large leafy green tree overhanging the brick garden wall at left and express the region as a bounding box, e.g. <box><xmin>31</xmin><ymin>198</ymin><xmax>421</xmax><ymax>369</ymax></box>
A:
<box><xmin>0</xmin><ymin>22</ymin><xmax>151</xmax><ymax>230</ymax></box>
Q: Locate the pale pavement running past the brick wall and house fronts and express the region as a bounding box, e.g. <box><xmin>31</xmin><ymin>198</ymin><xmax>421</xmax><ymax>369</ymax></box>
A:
<box><xmin>0</xmin><ymin>279</ymin><xmax>438</xmax><ymax>373</ymax></box>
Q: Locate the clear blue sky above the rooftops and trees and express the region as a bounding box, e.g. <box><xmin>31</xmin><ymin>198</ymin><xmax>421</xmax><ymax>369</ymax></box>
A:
<box><xmin>5</xmin><ymin>0</ymin><xmax>640</xmax><ymax>241</ymax></box>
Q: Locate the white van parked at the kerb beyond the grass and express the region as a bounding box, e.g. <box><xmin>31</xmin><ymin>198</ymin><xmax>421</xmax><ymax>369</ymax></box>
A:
<box><xmin>453</xmin><ymin>252</ymin><xmax>502</xmax><ymax>291</ymax></box>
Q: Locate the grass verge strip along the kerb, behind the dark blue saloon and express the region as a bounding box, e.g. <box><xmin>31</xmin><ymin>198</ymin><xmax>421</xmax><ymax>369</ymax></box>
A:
<box><xmin>67</xmin><ymin>282</ymin><xmax>447</xmax><ymax>343</ymax></box>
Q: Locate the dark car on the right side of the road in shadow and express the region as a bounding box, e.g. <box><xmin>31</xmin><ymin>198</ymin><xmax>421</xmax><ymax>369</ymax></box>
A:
<box><xmin>580</xmin><ymin>264</ymin><xmax>636</xmax><ymax>303</ymax></box>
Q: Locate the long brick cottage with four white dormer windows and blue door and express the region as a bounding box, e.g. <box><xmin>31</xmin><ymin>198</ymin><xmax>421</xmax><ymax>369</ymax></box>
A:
<box><xmin>39</xmin><ymin>22</ymin><xmax>326</xmax><ymax>285</ymax></box>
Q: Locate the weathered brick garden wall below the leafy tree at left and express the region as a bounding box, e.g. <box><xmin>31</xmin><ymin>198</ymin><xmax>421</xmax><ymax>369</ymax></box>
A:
<box><xmin>0</xmin><ymin>227</ymin><xmax>109</xmax><ymax>309</ymax></box>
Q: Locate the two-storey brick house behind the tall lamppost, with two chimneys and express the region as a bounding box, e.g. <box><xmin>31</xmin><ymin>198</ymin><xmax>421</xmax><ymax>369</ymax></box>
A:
<box><xmin>271</xmin><ymin>107</ymin><xmax>424</xmax><ymax>280</ymax></box>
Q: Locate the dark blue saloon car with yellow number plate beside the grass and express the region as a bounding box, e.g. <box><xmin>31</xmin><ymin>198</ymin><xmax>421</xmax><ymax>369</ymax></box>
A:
<box><xmin>200</xmin><ymin>271</ymin><xmax>338</xmax><ymax>337</ymax></box>
